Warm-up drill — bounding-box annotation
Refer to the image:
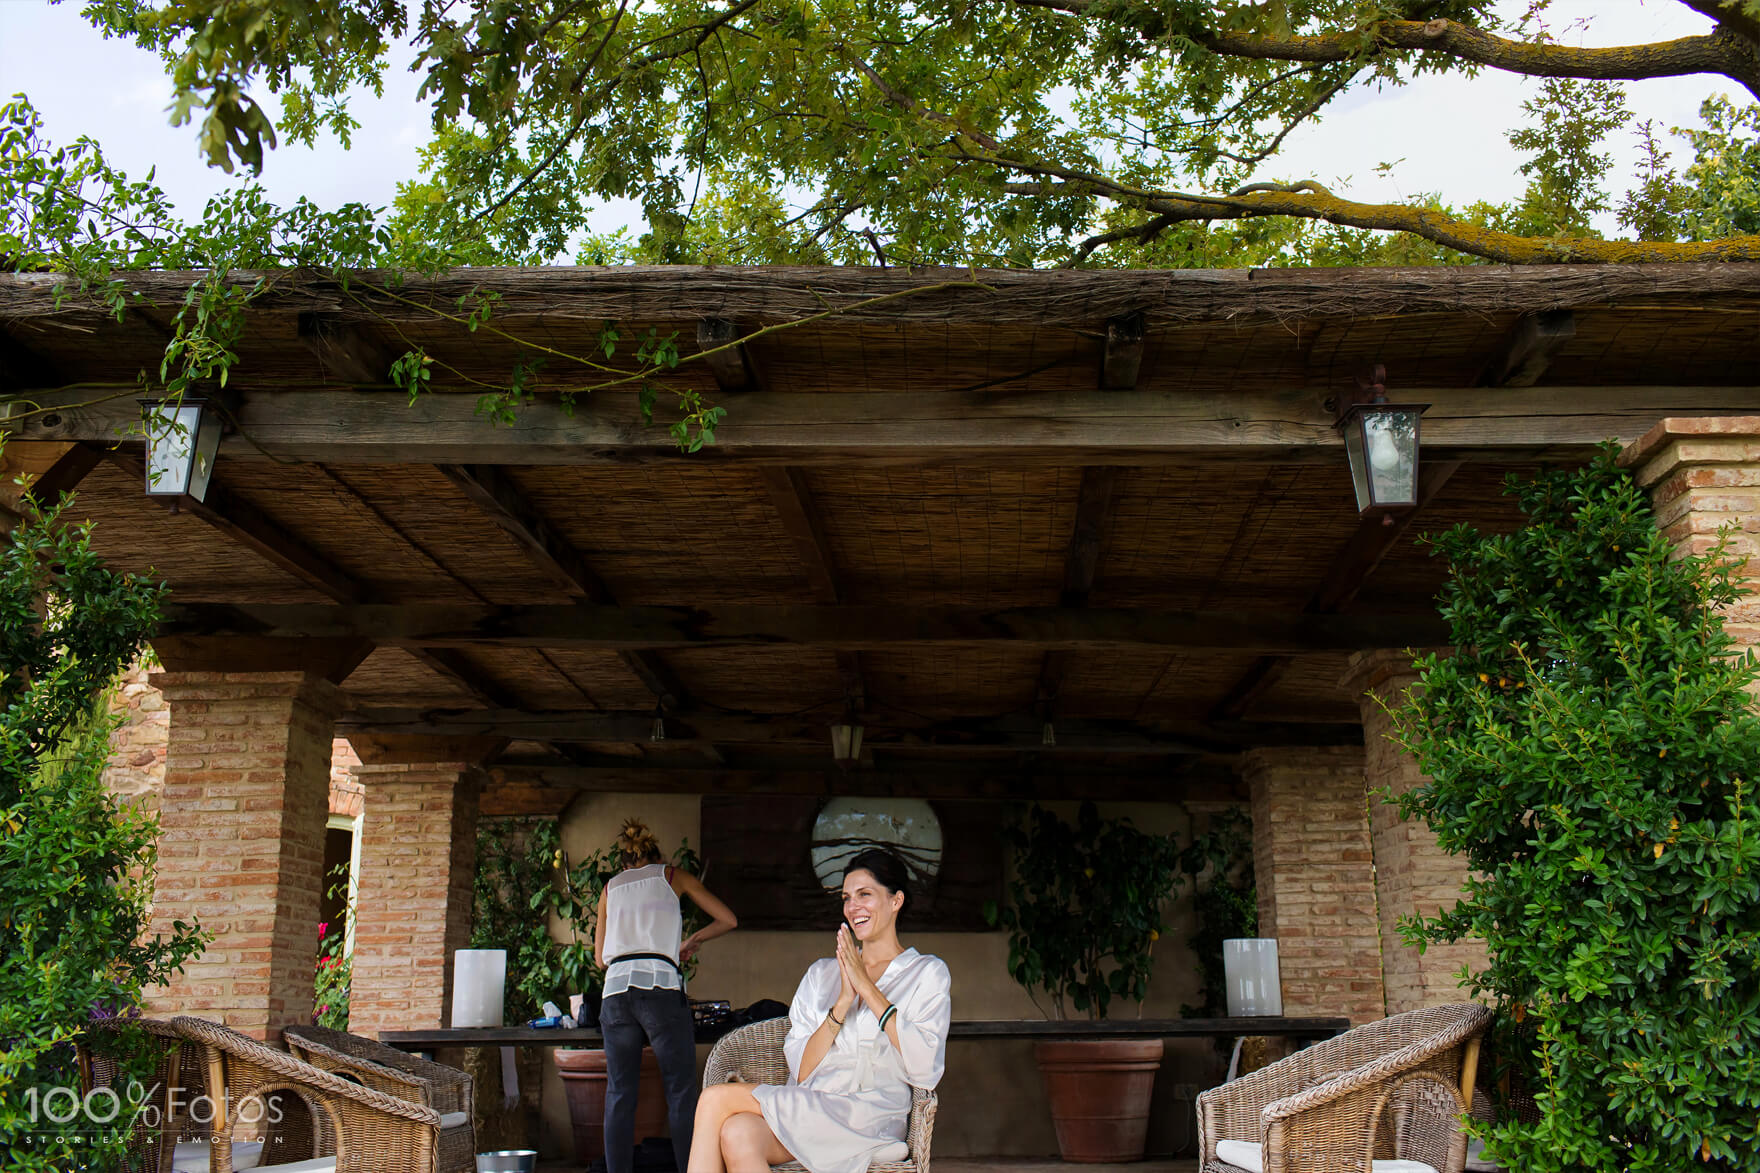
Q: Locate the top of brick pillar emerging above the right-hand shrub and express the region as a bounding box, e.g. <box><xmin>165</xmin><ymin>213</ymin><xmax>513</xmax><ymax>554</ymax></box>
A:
<box><xmin>1619</xmin><ymin>416</ymin><xmax>1760</xmax><ymax>703</ymax></box>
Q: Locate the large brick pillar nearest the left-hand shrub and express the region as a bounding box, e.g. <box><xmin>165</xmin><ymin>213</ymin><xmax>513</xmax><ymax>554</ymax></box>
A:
<box><xmin>148</xmin><ymin>671</ymin><xmax>341</xmax><ymax>1039</ymax></box>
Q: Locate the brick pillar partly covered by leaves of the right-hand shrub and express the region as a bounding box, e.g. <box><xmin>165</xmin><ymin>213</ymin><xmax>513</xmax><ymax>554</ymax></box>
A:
<box><xmin>1339</xmin><ymin>650</ymin><xmax>1485</xmax><ymax>1014</ymax></box>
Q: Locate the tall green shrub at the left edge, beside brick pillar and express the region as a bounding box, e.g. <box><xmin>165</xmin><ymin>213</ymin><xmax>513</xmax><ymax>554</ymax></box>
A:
<box><xmin>0</xmin><ymin>493</ymin><xmax>201</xmax><ymax>1171</ymax></box>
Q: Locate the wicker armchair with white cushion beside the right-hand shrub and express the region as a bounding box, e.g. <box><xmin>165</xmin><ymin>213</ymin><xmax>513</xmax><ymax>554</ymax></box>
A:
<box><xmin>1199</xmin><ymin>1002</ymin><xmax>1491</xmax><ymax>1173</ymax></box>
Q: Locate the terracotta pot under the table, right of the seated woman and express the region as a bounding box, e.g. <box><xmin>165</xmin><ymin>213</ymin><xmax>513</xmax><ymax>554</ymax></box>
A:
<box><xmin>1033</xmin><ymin>1039</ymin><xmax>1163</xmax><ymax>1162</ymax></box>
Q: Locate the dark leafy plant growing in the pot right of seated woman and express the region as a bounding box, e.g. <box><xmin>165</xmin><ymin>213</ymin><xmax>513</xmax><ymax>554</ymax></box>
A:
<box><xmin>984</xmin><ymin>803</ymin><xmax>1181</xmax><ymax>1018</ymax></box>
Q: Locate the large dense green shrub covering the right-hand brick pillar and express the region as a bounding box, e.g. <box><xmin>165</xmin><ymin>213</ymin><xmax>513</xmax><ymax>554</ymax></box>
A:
<box><xmin>1397</xmin><ymin>447</ymin><xmax>1760</xmax><ymax>1173</ymax></box>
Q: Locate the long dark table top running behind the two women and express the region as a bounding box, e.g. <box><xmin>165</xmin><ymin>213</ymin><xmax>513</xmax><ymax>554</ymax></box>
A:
<box><xmin>378</xmin><ymin>1018</ymin><xmax>1350</xmax><ymax>1051</ymax></box>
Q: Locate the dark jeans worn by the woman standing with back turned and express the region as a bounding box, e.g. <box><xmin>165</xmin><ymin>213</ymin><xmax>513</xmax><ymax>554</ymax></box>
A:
<box><xmin>598</xmin><ymin>990</ymin><xmax>697</xmax><ymax>1173</ymax></box>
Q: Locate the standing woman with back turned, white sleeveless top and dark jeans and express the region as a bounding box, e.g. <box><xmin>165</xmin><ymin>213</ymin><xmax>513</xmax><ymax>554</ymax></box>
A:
<box><xmin>593</xmin><ymin>819</ymin><xmax>739</xmax><ymax>1173</ymax></box>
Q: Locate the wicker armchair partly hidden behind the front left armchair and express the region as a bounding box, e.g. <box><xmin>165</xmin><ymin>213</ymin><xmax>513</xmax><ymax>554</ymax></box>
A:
<box><xmin>282</xmin><ymin>1027</ymin><xmax>477</xmax><ymax>1173</ymax></box>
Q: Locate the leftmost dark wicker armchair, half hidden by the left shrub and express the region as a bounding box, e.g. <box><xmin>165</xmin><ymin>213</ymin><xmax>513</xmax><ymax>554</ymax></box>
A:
<box><xmin>79</xmin><ymin>1018</ymin><xmax>208</xmax><ymax>1173</ymax></box>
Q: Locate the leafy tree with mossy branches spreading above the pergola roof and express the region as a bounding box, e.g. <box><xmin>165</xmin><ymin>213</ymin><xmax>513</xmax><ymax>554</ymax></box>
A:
<box><xmin>68</xmin><ymin>0</ymin><xmax>1760</xmax><ymax>266</ymax></box>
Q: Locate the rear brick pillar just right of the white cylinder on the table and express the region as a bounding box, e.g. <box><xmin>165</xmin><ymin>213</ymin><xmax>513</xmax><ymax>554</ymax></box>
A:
<box><xmin>1241</xmin><ymin>747</ymin><xmax>1383</xmax><ymax>1023</ymax></box>
